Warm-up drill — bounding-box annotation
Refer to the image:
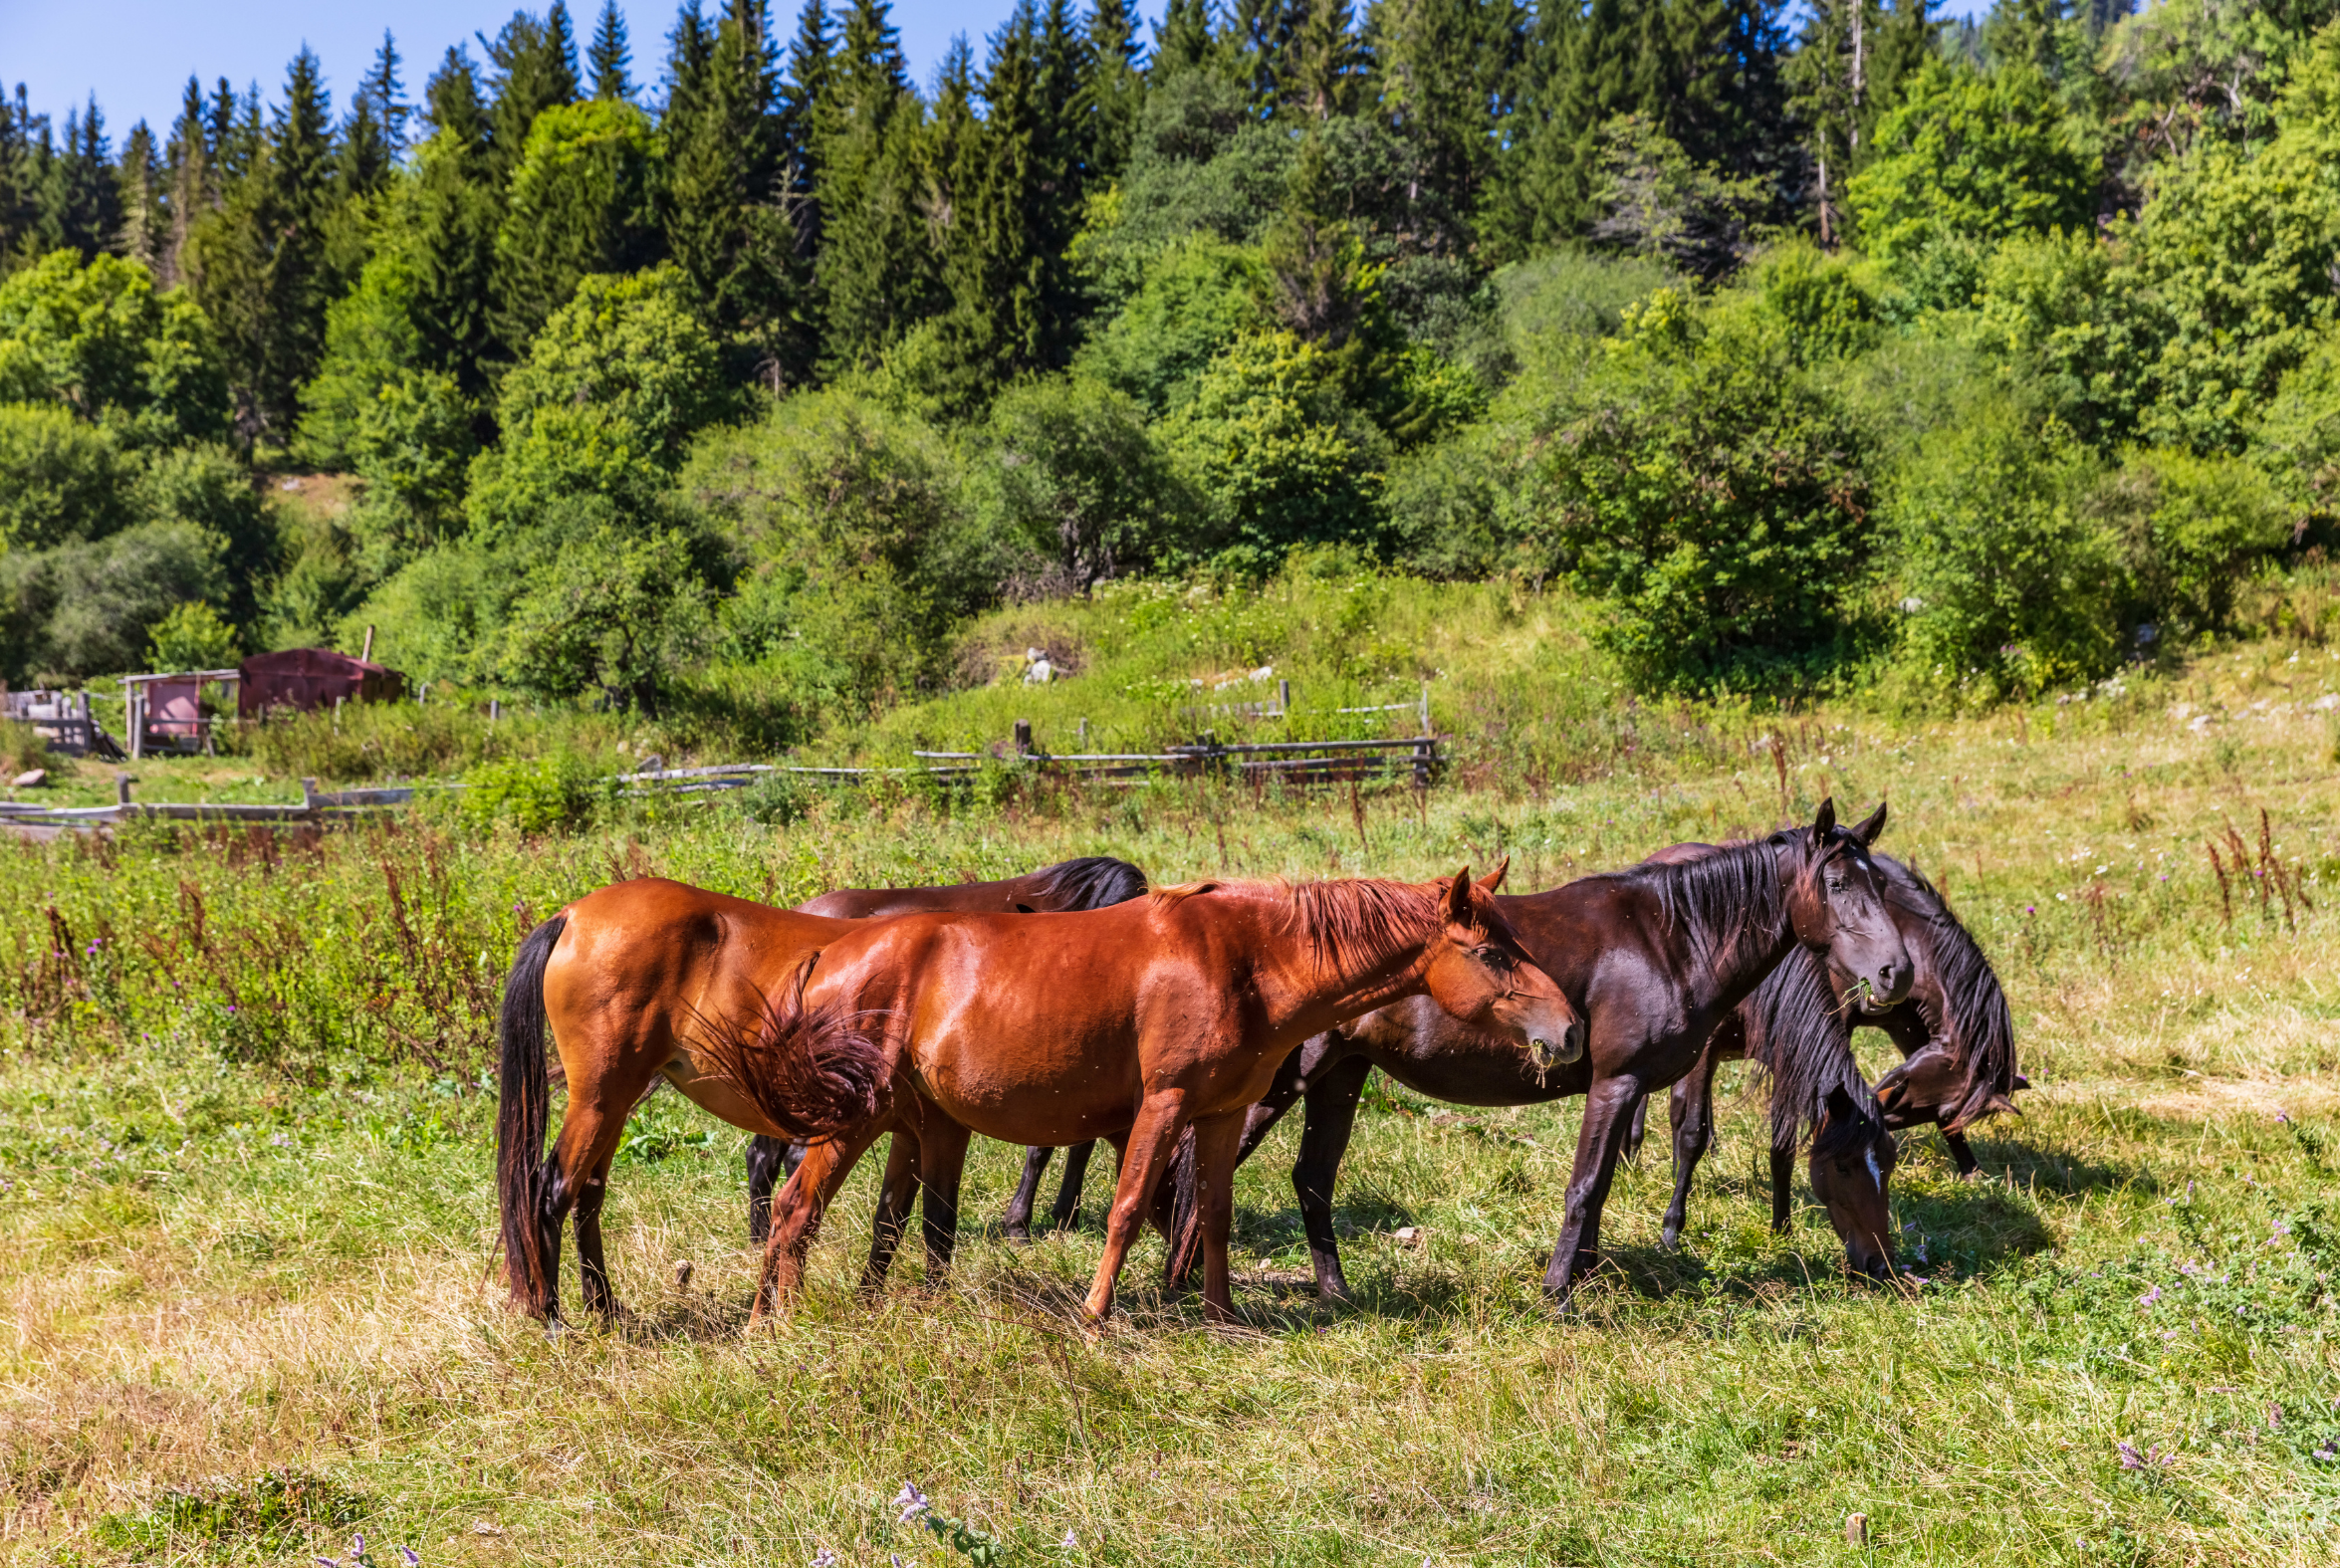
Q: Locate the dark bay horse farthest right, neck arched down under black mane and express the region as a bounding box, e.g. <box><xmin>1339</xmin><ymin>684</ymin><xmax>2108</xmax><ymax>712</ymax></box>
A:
<box><xmin>1666</xmin><ymin>854</ymin><xmax>2028</xmax><ymax>1245</ymax></box>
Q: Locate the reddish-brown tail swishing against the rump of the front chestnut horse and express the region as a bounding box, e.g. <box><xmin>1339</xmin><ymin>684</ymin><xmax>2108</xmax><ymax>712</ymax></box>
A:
<box><xmin>690</xmin><ymin>953</ymin><xmax>887</xmax><ymax>1145</ymax></box>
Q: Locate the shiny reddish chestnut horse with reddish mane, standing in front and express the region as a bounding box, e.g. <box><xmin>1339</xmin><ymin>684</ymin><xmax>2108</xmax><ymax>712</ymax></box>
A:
<box><xmin>716</xmin><ymin>870</ymin><xmax>1584</xmax><ymax>1320</ymax></box>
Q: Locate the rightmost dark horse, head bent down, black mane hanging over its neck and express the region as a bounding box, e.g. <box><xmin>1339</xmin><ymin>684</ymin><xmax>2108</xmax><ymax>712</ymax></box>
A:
<box><xmin>1666</xmin><ymin>854</ymin><xmax>2028</xmax><ymax>1245</ymax></box>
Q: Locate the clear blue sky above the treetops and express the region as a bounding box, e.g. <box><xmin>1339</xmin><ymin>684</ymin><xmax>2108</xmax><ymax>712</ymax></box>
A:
<box><xmin>0</xmin><ymin>0</ymin><xmax>1985</xmax><ymax>145</ymax></box>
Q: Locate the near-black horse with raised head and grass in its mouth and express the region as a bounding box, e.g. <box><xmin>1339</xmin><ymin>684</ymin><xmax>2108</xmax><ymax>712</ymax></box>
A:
<box><xmin>1160</xmin><ymin>802</ymin><xmax>1910</xmax><ymax>1310</ymax></box>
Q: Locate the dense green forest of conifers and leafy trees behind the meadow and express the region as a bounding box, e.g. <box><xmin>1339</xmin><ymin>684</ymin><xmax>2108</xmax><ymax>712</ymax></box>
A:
<box><xmin>0</xmin><ymin>0</ymin><xmax>2340</xmax><ymax>747</ymax></box>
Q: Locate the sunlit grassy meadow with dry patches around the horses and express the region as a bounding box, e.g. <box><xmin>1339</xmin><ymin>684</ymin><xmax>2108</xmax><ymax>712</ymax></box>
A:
<box><xmin>0</xmin><ymin>608</ymin><xmax>2340</xmax><ymax>1568</ymax></box>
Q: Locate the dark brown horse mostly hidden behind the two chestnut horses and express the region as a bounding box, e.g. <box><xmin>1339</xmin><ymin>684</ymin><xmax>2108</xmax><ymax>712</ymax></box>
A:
<box><xmin>747</xmin><ymin>854</ymin><xmax>1147</xmax><ymax>1247</ymax></box>
